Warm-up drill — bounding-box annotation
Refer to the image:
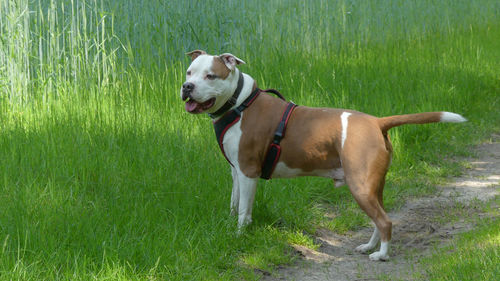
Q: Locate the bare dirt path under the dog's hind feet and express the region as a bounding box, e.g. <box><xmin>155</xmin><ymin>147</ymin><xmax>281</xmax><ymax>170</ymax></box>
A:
<box><xmin>263</xmin><ymin>135</ymin><xmax>500</xmax><ymax>281</ymax></box>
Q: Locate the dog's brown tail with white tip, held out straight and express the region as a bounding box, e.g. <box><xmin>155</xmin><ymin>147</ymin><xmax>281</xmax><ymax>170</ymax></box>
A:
<box><xmin>378</xmin><ymin>111</ymin><xmax>467</xmax><ymax>134</ymax></box>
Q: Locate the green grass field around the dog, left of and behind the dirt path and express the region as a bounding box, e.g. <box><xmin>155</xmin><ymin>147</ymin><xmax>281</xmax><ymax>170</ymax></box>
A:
<box><xmin>0</xmin><ymin>0</ymin><xmax>500</xmax><ymax>280</ymax></box>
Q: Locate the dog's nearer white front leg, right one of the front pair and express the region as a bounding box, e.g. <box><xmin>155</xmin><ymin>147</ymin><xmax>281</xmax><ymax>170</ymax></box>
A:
<box><xmin>237</xmin><ymin>172</ymin><xmax>257</xmax><ymax>230</ymax></box>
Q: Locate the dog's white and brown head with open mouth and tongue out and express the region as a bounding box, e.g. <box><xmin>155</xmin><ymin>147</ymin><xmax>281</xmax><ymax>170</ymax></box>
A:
<box><xmin>181</xmin><ymin>50</ymin><xmax>245</xmax><ymax>113</ymax></box>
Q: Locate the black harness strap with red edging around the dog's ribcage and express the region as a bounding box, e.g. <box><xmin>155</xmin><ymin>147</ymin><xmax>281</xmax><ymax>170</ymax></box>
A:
<box><xmin>260</xmin><ymin>102</ymin><xmax>297</xmax><ymax>180</ymax></box>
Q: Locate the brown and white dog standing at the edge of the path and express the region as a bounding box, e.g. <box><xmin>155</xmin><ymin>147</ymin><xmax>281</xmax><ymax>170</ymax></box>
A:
<box><xmin>180</xmin><ymin>50</ymin><xmax>466</xmax><ymax>260</ymax></box>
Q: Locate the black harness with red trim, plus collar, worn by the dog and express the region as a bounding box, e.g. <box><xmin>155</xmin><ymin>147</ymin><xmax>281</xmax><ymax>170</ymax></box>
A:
<box><xmin>210</xmin><ymin>75</ymin><xmax>297</xmax><ymax>180</ymax></box>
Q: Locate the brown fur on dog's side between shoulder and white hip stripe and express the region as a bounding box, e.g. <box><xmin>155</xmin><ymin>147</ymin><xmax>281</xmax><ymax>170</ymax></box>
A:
<box><xmin>238</xmin><ymin>94</ymin><xmax>360</xmax><ymax>177</ymax></box>
